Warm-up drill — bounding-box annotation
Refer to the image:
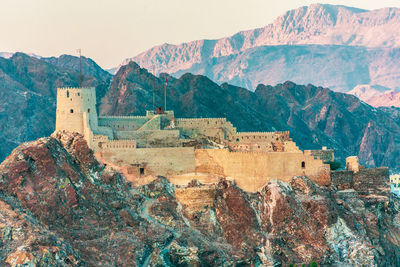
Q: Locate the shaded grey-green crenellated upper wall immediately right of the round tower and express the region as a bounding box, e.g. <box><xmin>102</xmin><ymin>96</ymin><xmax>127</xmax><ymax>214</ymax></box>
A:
<box><xmin>99</xmin><ymin>116</ymin><xmax>149</xmax><ymax>131</ymax></box>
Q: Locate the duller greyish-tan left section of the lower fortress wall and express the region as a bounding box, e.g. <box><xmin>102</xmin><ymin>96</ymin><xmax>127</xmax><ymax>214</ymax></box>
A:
<box><xmin>100</xmin><ymin>147</ymin><xmax>195</xmax><ymax>176</ymax></box>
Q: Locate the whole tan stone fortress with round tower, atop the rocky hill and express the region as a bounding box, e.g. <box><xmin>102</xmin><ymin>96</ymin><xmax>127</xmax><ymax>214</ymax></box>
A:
<box><xmin>56</xmin><ymin>88</ymin><xmax>333</xmax><ymax>191</ymax></box>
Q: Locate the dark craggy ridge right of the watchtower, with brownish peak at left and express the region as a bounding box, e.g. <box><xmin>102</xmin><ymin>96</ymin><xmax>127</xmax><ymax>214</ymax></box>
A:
<box><xmin>100</xmin><ymin>63</ymin><xmax>400</xmax><ymax>169</ymax></box>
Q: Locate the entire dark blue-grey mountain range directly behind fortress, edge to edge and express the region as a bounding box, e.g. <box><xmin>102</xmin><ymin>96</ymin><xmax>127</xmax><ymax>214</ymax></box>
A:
<box><xmin>0</xmin><ymin>53</ymin><xmax>400</xmax><ymax>170</ymax></box>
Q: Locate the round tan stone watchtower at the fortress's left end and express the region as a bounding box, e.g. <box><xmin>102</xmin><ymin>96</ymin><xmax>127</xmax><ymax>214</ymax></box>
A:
<box><xmin>56</xmin><ymin>87</ymin><xmax>97</xmax><ymax>134</ymax></box>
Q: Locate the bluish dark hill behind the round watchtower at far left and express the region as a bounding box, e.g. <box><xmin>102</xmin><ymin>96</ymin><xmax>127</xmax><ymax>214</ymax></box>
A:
<box><xmin>0</xmin><ymin>53</ymin><xmax>111</xmax><ymax>161</ymax></box>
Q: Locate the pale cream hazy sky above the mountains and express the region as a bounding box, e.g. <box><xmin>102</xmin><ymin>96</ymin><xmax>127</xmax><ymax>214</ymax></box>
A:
<box><xmin>0</xmin><ymin>0</ymin><xmax>400</xmax><ymax>68</ymax></box>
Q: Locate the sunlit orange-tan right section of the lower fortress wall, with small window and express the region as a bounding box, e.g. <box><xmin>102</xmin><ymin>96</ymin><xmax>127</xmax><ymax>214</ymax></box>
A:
<box><xmin>196</xmin><ymin>149</ymin><xmax>330</xmax><ymax>191</ymax></box>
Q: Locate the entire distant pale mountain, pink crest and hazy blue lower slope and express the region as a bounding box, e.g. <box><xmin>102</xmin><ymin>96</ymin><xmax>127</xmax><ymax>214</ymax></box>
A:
<box><xmin>122</xmin><ymin>4</ymin><xmax>400</xmax><ymax>92</ymax></box>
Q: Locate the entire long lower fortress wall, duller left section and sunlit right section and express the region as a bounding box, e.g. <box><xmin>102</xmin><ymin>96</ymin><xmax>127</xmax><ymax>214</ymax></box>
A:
<box><xmin>100</xmin><ymin>147</ymin><xmax>330</xmax><ymax>192</ymax></box>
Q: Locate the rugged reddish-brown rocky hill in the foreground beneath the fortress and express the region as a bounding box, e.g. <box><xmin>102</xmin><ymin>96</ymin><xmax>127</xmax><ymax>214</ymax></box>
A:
<box><xmin>0</xmin><ymin>133</ymin><xmax>400</xmax><ymax>266</ymax></box>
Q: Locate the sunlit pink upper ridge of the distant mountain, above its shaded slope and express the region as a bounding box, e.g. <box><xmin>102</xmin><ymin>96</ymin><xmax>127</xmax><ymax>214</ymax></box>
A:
<box><xmin>129</xmin><ymin>4</ymin><xmax>400</xmax><ymax>76</ymax></box>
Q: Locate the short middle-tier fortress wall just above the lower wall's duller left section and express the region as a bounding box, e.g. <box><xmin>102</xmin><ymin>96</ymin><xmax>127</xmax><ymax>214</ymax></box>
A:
<box><xmin>115</xmin><ymin>130</ymin><xmax>181</xmax><ymax>147</ymax></box>
